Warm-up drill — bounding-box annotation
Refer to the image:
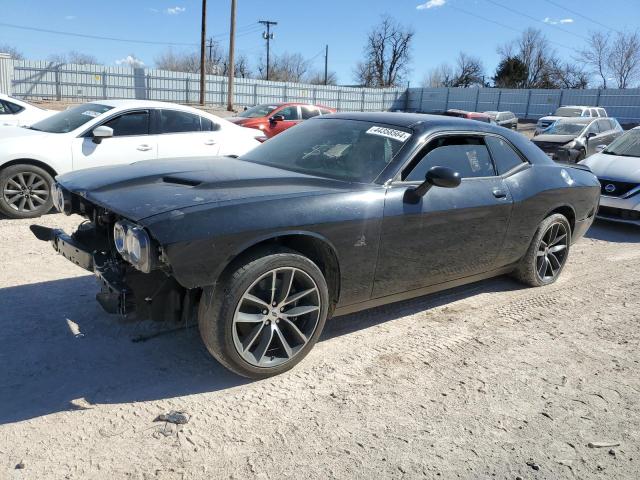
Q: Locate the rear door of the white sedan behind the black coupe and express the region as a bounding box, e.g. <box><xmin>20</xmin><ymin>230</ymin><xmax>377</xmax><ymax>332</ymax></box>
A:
<box><xmin>158</xmin><ymin>109</ymin><xmax>223</xmax><ymax>158</ymax></box>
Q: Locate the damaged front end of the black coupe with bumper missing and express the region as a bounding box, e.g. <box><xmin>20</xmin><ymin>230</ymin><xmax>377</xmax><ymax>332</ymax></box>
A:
<box><xmin>31</xmin><ymin>186</ymin><xmax>199</xmax><ymax>322</ymax></box>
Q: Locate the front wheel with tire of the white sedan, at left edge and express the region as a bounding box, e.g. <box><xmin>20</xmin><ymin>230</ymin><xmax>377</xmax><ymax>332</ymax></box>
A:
<box><xmin>0</xmin><ymin>164</ymin><xmax>53</xmax><ymax>218</ymax></box>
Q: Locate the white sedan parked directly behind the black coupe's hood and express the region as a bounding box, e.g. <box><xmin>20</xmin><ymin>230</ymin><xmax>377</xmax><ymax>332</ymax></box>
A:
<box><xmin>0</xmin><ymin>100</ymin><xmax>263</xmax><ymax>218</ymax></box>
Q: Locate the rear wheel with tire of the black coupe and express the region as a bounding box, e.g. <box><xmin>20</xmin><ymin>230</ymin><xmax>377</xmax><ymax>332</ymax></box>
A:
<box><xmin>513</xmin><ymin>213</ymin><xmax>571</xmax><ymax>287</ymax></box>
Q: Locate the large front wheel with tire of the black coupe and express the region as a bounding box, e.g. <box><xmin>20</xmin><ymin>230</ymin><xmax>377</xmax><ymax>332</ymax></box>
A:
<box><xmin>198</xmin><ymin>248</ymin><xmax>329</xmax><ymax>379</ymax></box>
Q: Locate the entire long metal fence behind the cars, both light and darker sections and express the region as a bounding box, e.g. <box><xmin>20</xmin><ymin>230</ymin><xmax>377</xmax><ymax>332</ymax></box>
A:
<box><xmin>7</xmin><ymin>60</ymin><xmax>640</xmax><ymax>123</ymax></box>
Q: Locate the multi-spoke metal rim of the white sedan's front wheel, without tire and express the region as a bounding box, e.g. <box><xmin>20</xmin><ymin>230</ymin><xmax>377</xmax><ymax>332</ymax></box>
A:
<box><xmin>2</xmin><ymin>172</ymin><xmax>50</xmax><ymax>213</ymax></box>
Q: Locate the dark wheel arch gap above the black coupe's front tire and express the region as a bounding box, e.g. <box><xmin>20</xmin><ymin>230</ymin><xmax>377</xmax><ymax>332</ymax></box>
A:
<box><xmin>218</xmin><ymin>230</ymin><xmax>340</xmax><ymax>313</ymax></box>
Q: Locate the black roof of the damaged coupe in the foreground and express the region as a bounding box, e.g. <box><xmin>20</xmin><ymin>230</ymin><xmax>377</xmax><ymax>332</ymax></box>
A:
<box><xmin>315</xmin><ymin>112</ymin><xmax>504</xmax><ymax>132</ymax></box>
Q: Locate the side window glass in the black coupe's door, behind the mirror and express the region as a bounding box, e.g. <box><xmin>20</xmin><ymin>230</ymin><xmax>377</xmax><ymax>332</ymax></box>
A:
<box><xmin>403</xmin><ymin>135</ymin><xmax>496</xmax><ymax>182</ymax></box>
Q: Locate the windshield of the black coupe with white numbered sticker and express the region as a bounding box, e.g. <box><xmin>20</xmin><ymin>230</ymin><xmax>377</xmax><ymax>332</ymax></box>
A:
<box><xmin>240</xmin><ymin>118</ymin><xmax>411</xmax><ymax>183</ymax></box>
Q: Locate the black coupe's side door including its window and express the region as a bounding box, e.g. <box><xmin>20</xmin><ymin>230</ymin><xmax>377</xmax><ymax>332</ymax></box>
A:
<box><xmin>373</xmin><ymin>135</ymin><xmax>513</xmax><ymax>298</ymax></box>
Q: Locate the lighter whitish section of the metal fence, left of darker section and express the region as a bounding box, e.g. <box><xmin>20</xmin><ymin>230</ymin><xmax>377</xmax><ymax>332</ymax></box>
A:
<box><xmin>7</xmin><ymin>61</ymin><xmax>405</xmax><ymax>111</ymax></box>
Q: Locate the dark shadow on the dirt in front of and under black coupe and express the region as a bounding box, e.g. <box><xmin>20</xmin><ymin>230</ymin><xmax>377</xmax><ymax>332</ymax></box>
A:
<box><xmin>0</xmin><ymin>276</ymin><xmax>520</xmax><ymax>424</ymax></box>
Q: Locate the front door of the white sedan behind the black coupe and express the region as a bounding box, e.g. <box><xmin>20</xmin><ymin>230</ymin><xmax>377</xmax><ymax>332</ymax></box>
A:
<box><xmin>71</xmin><ymin>110</ymin><xmax>158</xmax><ymax>170</ymax></box>
